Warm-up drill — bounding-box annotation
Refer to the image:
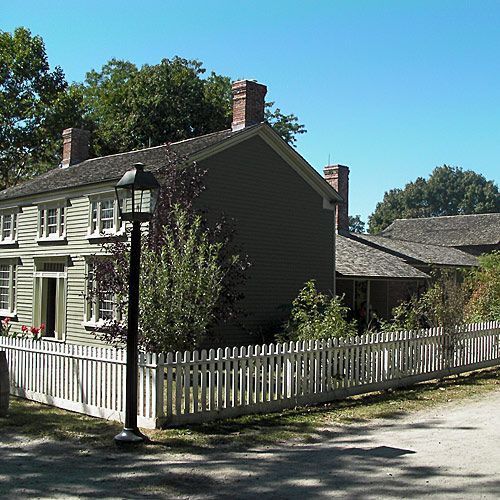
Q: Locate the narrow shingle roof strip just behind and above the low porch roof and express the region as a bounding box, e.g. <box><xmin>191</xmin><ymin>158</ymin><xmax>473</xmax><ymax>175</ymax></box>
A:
<box><xmin>353</xmin><ymin>234</ymin><xmax>477</xmax><ymax>266</ymax></box>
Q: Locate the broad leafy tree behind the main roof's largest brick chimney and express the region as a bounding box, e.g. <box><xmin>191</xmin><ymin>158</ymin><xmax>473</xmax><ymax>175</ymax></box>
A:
<box><xmin>84</xmin><ymin>57</ymin><xmax>305</xmax><ymax>155</ymax></box>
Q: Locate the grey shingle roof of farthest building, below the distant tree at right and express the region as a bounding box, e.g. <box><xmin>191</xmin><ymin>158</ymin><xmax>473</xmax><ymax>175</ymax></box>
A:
<box><xmin>381</xmin><ymin>213</ymin><xmax>500</xmax><ymax>247</ymax></box>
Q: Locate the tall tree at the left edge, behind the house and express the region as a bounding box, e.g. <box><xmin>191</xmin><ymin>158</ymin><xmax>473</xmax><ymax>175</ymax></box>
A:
<box><xmin>0</xmin><ymin>28</ymin><xmax>86</xmax><ymax>189</ymax></box>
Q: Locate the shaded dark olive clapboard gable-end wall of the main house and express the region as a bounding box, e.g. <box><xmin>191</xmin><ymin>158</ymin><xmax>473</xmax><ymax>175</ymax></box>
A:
<box><xmin>199</xmin><ymin>137</ymin><xmax>335</xmax><ymax>344</ymax></box>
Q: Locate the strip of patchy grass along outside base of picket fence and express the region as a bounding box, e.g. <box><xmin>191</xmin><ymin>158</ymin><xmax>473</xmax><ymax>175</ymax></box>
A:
<box><xmin>0</xmin><ymin>367</ymin><xmax>500</xmax><ymax>452</ymax></box>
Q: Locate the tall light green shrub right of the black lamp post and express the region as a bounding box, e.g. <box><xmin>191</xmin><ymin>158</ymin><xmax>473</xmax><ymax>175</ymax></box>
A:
<box><xmin>139</xmin><ymin>206</ymin><xmax>226</xmax><ymax>352</ymax></box>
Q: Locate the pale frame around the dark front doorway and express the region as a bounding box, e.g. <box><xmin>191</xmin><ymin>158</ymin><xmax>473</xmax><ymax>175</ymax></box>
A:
<box><xmin>33</xmin><ymin>256</ymin><xmax>68</xmax><ymax>342</ymax></box>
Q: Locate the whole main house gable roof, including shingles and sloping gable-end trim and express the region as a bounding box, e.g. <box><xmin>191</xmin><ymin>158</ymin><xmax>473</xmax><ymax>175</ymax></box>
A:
<box><xmin>0</xmin><ymin>122</ymin><xmax>340</xmax><ymax>203</ymax></box>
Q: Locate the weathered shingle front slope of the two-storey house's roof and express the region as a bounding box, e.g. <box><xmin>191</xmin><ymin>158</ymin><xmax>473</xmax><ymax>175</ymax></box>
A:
<box><xmin>0</xmin><ymin>125</ymin><xmax>240</xmax><ymax>201</ymax></box>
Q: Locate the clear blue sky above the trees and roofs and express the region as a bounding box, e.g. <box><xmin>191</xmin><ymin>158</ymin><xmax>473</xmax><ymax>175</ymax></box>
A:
<box><xmin>0</xmin><ymin>0</ymin><xmax>500</xmax><ymax>220</ymax></box>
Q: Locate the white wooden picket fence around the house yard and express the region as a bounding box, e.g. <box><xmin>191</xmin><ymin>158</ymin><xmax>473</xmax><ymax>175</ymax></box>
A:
<box><xmin>0</xmin><ymin>322</ymin><xmax>500</xmax><ymax>428</ymax></box>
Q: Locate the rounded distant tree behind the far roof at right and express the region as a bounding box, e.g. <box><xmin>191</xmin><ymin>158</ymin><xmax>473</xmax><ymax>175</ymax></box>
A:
<box><xmin>368</xmin><ymin>165</ymin><xmax>500</xmax><ymax>234</ymax></box>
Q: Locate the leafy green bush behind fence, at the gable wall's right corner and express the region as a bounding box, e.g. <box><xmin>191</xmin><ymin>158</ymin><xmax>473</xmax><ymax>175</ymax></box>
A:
<box><xmin>279</xmin><ymin>280</ymin><xmax>357</xmax><ymax>341</ymax></box>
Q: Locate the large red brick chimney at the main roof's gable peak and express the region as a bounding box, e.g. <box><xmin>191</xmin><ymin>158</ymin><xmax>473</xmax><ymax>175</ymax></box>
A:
<box><xmin>231</xmin><ymin>80</ymin><xmax>267</xmax><ymax>130</ymax></box>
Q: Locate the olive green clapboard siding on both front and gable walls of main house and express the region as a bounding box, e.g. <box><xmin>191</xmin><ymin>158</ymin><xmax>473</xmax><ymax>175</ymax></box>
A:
<box><xmin>0</xmin><ymin>137</ymin><xmax>335</xmax><ymax>345</ymax></box>
